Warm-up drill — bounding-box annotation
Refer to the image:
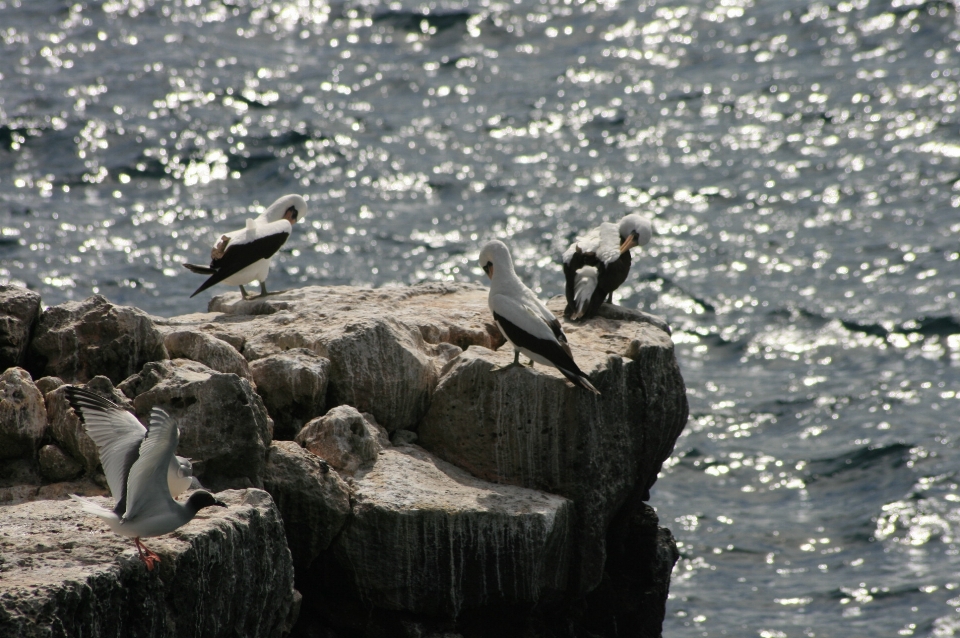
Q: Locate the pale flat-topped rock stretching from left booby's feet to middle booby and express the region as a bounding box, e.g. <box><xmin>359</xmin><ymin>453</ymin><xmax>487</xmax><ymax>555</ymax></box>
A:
<box><xmin>155</xmin><ymin>284</ymin><xmax>503</xmax><ymax>432</ymax></box>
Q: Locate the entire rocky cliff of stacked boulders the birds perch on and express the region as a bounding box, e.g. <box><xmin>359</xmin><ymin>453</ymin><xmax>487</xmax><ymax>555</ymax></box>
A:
<box><xmin>0</xmin><ymin>285</ymin><xmax>687</xmax><ymax>636</ymax></box>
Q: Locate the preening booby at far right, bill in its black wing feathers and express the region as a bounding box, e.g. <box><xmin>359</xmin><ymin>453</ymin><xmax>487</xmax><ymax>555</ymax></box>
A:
<box><xmin>563</xmin><ymin>213</ymin><xmax>653</xmax><ymax>319</ymax></box>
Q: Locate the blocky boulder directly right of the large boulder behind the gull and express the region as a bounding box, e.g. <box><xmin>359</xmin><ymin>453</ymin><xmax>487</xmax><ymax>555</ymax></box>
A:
<box><xmin>250</xmin><ymin>348</ymin><xmax>330</xmax><ymax>441</ymax></box>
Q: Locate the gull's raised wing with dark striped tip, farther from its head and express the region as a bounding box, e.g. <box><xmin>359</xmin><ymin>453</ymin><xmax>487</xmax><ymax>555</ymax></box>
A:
<box><xmin>66</xmin><ymin>386</ymin><xmax>147</xmax><ymax>514</ymax></box>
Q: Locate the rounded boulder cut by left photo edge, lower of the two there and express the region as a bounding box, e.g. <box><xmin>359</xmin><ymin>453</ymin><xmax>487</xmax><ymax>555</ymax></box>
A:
<box><xmin>0</xmin><ymin>367</ymin><xmax>47</xmax><ymax>460</ymax></box>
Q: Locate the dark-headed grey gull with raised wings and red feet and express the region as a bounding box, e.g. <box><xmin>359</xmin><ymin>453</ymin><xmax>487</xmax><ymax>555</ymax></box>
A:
<box><xmin>66</xmin><ymin>386</ymin><xmax>226</xmax><ymax>571</ymax></box>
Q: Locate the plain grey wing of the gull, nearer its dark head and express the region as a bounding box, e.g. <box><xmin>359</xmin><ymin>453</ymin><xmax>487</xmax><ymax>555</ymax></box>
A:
<box><xmin>123</xmin><ymin>408</ymin><xmax>180</xmax><ymax>521</ymax></box>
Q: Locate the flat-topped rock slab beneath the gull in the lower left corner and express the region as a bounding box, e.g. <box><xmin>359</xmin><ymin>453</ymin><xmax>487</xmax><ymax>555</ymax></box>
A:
<box><xmin>0</xmin><ymin>490</ymin><xmax>296</xmax><ymax>638</ymax></box>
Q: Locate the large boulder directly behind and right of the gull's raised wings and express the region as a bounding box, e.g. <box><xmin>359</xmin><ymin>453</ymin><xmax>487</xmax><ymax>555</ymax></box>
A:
<box><xmin>120</xmin><ymin>359</ymin><xmax>272</xmax><ymax>489</ymax></box>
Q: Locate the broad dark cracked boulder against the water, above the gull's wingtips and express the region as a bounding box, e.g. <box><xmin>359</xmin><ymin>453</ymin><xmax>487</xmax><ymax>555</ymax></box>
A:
<box><xmin>27</xmin><ymin>295</ymin><xmax>167</xmax><ymax>383</ymax></box>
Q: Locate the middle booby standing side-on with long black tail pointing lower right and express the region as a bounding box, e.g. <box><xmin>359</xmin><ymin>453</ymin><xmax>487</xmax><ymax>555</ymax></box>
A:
<box><xmin>480</xmin><ymin>240</ymin><xmax>600</xmax><ymax>394</ymax></box>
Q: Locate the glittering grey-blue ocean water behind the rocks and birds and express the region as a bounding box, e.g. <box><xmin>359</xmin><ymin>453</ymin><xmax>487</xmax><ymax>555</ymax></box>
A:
<box><xmin>0</xmin><ymin>0</ymin><xmax>960</xmax><ymax>638</ymax></box>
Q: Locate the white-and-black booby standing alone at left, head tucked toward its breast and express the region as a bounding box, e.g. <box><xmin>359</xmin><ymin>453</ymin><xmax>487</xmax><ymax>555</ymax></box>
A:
<box><xmin>183</xmin><ymin>195</ymin><xmax>307</xmax><ymax>299</ymax></box>
